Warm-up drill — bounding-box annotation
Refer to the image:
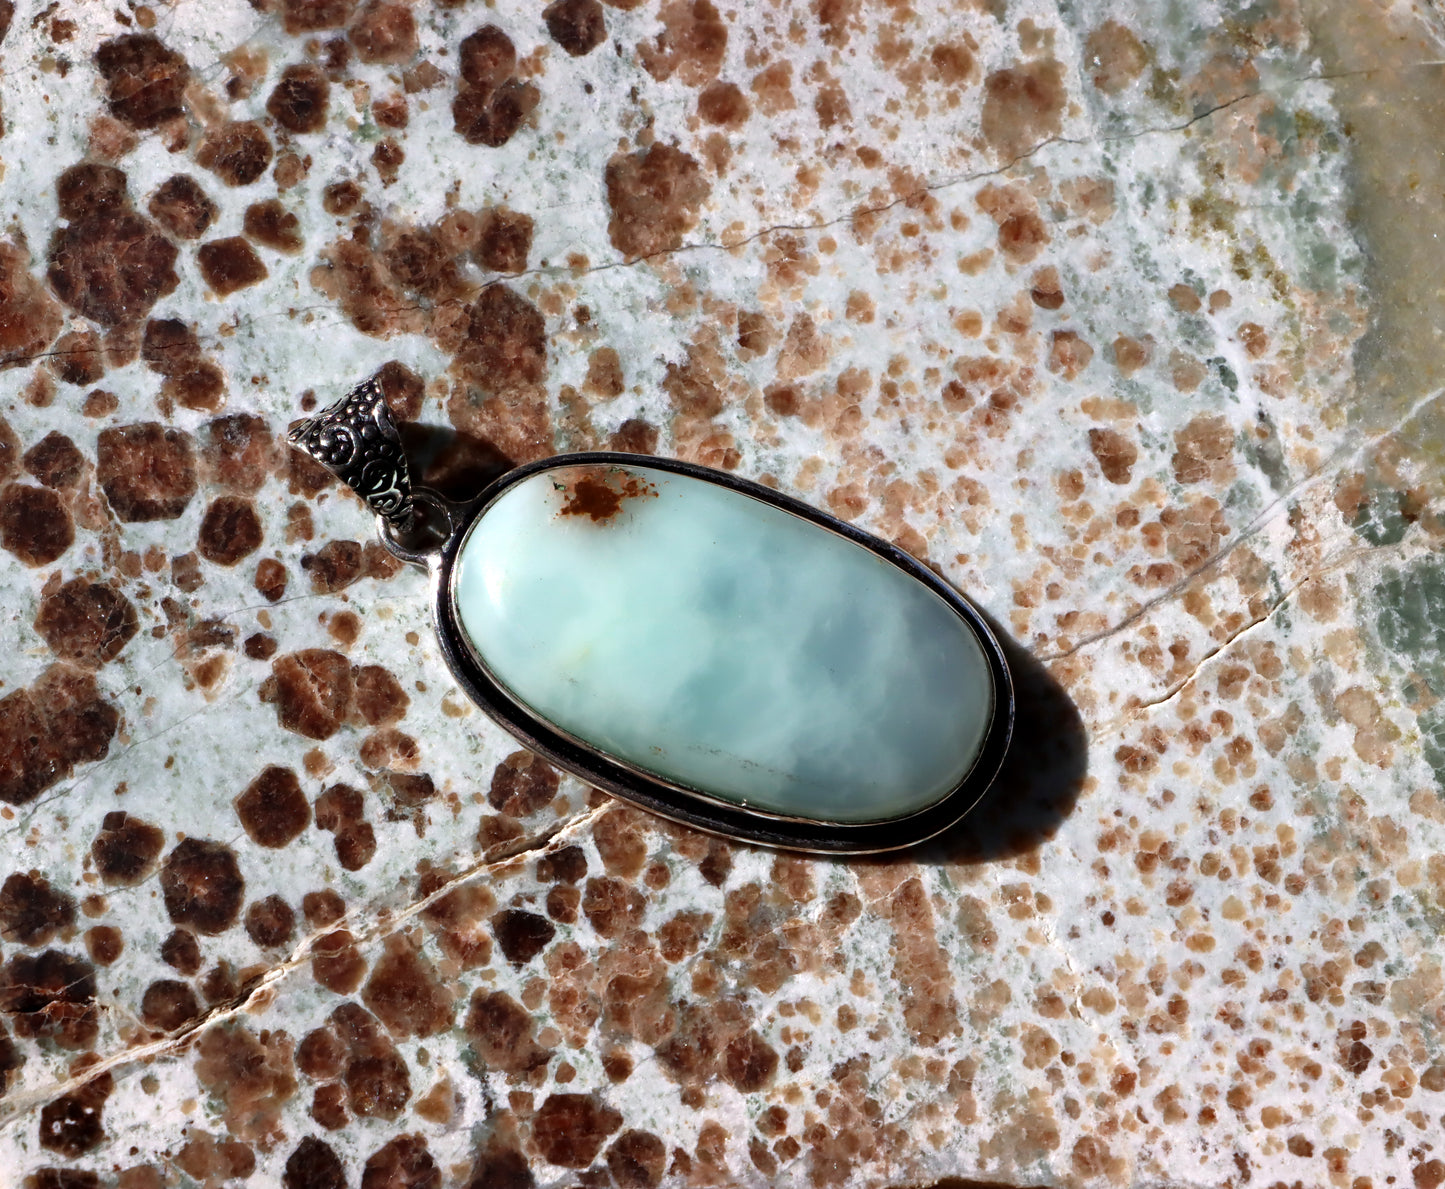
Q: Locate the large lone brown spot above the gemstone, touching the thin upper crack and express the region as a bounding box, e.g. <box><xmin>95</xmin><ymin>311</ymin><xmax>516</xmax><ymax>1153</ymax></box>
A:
<box><xmin>605</xmin><ymin>142</ymin><xmax>711</xmax><ymax>260</ymax></box>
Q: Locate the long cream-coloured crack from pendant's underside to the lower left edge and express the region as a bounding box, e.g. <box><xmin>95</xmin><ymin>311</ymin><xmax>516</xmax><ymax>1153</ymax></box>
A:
<box><xmin>0</xmin><ymin>797</ymin><xmax>616</xmax><ymax>1131</ymax></box>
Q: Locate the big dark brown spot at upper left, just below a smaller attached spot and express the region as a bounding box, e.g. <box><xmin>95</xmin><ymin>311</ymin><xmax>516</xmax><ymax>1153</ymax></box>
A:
<box><xmin>46</xmin><ymin>211</ymin><xmax>179</xmax><ymax>327</ymax></box>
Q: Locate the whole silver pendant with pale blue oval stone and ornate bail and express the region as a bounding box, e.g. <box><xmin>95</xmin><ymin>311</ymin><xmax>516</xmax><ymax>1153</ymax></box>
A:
<box><xmin>290</xmin><ymin>380</ymin><xmax>1013</xmax><ymax>854</ymax></box>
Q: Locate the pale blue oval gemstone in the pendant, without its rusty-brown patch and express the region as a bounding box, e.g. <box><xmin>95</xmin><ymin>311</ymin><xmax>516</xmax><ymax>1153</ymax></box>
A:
<box><xmin>454</xmin><ymin>465</ymin><xmax>993</xmax><ymax>822</ymax></box>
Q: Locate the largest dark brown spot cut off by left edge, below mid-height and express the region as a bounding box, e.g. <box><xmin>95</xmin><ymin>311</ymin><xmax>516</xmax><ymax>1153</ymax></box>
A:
<box><xmin>0</xmin><ymin>663</ymin><xmax>120</xmax><ymax>805</ymax></box>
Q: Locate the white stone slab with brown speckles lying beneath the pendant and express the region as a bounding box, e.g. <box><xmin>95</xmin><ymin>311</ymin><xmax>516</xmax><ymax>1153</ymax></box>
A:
<box><xmin>0</xmin><ymin>0</ymin><xmax>1445</xmax><ymax>1189</ymax></box>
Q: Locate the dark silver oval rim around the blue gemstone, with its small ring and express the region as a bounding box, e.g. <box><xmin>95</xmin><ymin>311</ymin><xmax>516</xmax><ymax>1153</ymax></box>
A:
<box><xmin>421</xmin><ymin>451</ymin><xmax>1014</xmax><ymax>854</ymax></box>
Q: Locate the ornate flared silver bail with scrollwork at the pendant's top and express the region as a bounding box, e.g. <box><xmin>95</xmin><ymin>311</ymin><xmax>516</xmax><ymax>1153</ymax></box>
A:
<box><xmin>286</xmin><ymin>377</ymin><xmax>416</xmax><ymax>533</ymax></box>
